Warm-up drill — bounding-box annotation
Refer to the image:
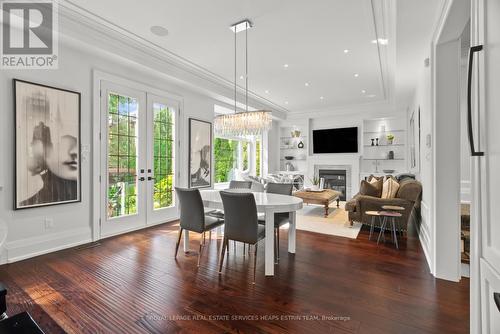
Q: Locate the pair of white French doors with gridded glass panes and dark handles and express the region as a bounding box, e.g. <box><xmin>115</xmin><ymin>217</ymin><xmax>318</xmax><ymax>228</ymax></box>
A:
<box><xmin>101</xmin><ymin>81</ymin><xmax>180</xmax><ymax>237</ymax></box>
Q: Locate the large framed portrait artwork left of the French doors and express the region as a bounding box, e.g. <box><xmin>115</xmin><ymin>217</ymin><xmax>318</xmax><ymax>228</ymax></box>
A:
<box><xmin>14</xmin><ymin>79</ymin><xmax>81</xmax><ymax>210</ymax></box>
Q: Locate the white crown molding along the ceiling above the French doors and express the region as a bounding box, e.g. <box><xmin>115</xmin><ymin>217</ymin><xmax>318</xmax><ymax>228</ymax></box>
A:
<box><xmin>59</xmin><ymin>0</ymin><xmax>288</xmax><ymax>119</ymax></box>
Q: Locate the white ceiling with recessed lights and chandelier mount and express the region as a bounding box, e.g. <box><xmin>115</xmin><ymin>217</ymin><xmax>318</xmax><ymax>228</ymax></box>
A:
<box><xmin>68</xmin><ymin>0</ymin><xmax>443</xmax><ymax>111</ymax></box>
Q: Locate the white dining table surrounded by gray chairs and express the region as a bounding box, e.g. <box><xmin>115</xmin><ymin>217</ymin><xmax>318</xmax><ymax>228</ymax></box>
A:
<box><xmin>184</xmin><ymin>189</ymin><xmax>302</xmax><ymax>276</ymax></box>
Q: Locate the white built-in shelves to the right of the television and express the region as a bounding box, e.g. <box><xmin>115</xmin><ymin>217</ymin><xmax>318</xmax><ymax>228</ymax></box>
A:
<box><xmin>360</xmin><ymin>117</ymin><xmax>408</xmax><ymax>179</ymax></box>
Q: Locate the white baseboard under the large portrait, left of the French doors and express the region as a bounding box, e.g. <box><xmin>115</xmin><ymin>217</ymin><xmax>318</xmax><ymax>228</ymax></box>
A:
<box><xmin>4</xmin><ymin>226</ymin><xmax>92</xmax><ymax>263</ymax></box>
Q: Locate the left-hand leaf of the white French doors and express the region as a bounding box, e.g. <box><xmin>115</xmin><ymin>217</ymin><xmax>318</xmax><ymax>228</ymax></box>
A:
<box><xmin>101</xmin><ymin>83</ymin><xmax>146</xmax><ymax>236</ymax></box>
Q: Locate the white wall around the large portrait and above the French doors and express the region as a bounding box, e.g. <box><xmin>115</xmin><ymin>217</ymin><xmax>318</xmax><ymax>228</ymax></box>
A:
<box><xmin>0</xmin><ymin>33</ymin><xmax>230</xmax><ymax>262</ymax></box>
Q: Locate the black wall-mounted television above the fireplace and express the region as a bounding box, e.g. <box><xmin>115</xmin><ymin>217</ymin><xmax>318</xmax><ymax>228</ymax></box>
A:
<box><xmin>313</xmin><ymin>127</ymin><xmax>358</xmax><ymax>154</ymax></box>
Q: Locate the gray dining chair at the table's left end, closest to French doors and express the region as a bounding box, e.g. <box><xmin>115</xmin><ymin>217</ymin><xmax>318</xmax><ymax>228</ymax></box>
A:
<box><xmin>175</xmin><ymin>187</ymin><xmax>224</xmax><ymax>267</ymax></box>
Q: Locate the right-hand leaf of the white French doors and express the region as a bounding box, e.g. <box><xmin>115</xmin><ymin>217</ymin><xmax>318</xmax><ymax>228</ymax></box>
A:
<box><xmin>148</xmin><ymin>94</ymin><xmax>179</xmax><ymax>224</ymax></box>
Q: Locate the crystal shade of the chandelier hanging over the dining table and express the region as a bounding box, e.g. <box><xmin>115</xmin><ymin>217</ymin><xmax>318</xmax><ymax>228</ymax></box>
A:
<box><xmin>214</xmin><ymin>110</ymin><xmax>272</xmax><ymax>137</ymax></box>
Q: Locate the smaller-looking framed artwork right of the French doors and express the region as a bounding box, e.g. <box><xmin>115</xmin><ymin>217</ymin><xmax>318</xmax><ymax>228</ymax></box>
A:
<box><xmin>189</xmin><ymin>118</ymin><xmax>212</xmax><ymax>188</ymax></box>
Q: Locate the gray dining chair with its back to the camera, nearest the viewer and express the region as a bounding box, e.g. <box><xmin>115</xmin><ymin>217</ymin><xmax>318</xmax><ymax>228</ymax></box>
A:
<box><xmin>219</xmin><ymin>191</ymin><xmax>266</xmax><ymax>284</ymax></box>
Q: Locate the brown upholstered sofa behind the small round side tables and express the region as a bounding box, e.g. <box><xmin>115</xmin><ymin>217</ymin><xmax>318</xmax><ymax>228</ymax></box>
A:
<box><xmin>345</xmin><ymin>176</ymin><xmax>422</xmax><ymax>230</ymax></box>
